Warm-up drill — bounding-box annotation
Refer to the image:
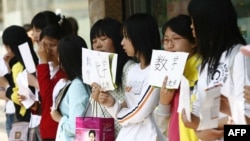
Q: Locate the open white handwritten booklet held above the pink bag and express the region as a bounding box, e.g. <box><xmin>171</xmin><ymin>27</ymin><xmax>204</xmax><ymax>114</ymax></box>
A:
<box><xmin>82</xmin><ymin>48</ymin><xmax>117</xmax><ymax>90</ymax></box>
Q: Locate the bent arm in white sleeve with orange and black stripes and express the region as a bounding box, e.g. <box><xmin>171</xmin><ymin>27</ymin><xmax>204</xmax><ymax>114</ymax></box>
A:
<box><xmin>95</xmin><ymin>75</ymin><xmax>160</xmax><ymax>125</ymax></box>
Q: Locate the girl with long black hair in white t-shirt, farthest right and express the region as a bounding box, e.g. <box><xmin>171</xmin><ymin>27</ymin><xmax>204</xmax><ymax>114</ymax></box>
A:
<box><xmin>183</xmin><ymin>0</ymin><xmax>250</xmax><ymax>140</ymax></box>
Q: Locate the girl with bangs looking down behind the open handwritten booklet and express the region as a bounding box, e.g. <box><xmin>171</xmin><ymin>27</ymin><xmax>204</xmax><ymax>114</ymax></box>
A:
<box><xmin>90</xmin><ymin>18</ymin><xmax>134</xmax><ymax>136</ymax></box>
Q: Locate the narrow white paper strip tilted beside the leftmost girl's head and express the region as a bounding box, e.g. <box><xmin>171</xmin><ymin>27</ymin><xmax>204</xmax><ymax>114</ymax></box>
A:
<box><xmin>18</xmin><ymin>42</ymin><xmax>36</xmax><ymax>73</ymax></box>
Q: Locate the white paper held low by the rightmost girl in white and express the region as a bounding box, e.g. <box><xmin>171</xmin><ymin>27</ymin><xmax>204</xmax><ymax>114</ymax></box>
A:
<box><xmin>197</xmin><ymin>85</ymin><xmax>221</xmax><ymax>130</ymax></box>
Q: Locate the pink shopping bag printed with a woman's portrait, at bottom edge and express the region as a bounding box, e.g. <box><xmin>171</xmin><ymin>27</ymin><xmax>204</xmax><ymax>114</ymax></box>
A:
<box><xmin>75</xmin><ymin>117</ymin><xmax>115</xmax><ymax>141</ymax></box>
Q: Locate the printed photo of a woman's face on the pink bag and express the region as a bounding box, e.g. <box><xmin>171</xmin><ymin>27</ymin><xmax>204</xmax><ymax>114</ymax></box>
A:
<box><xmin>75</xmin><ymin>128</ymin><xmax>100</xmax><ymax>141</ymax></box>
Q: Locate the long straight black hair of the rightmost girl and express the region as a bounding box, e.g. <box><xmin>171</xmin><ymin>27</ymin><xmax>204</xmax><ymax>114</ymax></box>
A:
<box><xmin>188</xmin><ymin>0</ymin><xmax>246</xmax><ymax>72</ymax></box>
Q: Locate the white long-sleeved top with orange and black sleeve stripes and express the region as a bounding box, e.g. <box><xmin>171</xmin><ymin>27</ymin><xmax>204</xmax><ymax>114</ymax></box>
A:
<box><xmin>106</xmin><ymin>64</ymin><xmax>165</xmax><ymax>141</ymax></box>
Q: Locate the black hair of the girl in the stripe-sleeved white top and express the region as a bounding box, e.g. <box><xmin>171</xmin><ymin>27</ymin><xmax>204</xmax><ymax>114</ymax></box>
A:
<box><xmin>123</xmin><ymin>13</ymin><xmax>161</xmax><ymax>65</ymax></box>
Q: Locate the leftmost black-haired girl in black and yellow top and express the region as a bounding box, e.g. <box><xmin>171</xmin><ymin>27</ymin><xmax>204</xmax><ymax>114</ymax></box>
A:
<box><xmin>1</xmin><ymin>25</ymin><xmax>38</xmax><ymax>122</ymax></box>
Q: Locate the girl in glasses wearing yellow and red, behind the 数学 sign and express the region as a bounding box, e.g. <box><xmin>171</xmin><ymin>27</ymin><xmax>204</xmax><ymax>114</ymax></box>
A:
<box><xmin>155</xmin><ymin>14</ymin><xmax>200</xmax><ymax>141</ymax></box>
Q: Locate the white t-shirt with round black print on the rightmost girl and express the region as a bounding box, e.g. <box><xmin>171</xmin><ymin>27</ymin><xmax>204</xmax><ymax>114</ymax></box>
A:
<box><xmin>193</xmin><ymin>45</ymin><xmax>249</xmax><ymax>140</ymax></box>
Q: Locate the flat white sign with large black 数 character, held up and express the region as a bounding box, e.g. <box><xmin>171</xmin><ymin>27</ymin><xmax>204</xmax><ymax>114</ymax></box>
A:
<box><xmin>149</xmin><ymin>50</ymin><xmax>188</xmax><ymax>89</ymax></box>
